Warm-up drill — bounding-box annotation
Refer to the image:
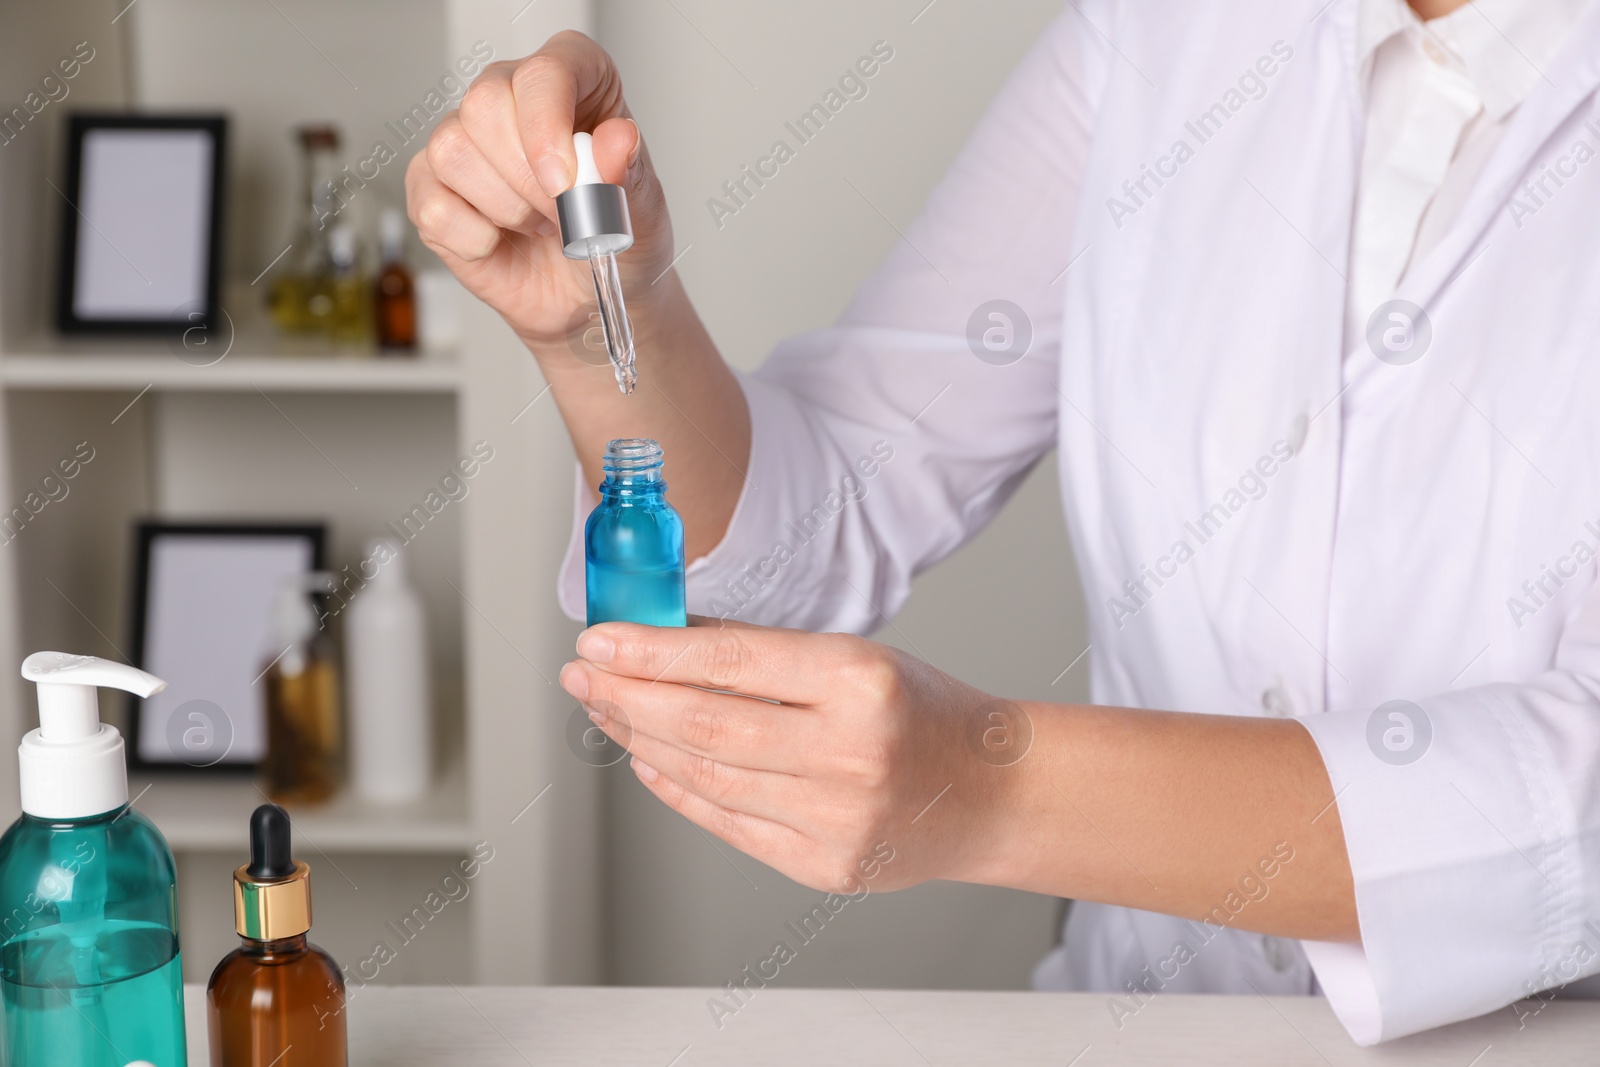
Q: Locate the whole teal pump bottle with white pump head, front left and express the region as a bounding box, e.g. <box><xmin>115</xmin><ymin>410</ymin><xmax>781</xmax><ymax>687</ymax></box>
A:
<box><xmin>0</xmin><ymin>653</ymin><xmax>187</xmax><ymax>1067</ymax></box>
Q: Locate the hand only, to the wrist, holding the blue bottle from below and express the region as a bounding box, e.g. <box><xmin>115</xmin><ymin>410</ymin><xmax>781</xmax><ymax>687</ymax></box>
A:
<box><xmin>562</xmin><ymin>619</ymin><xmax>1016</xmax><ymax>893</ymax></box>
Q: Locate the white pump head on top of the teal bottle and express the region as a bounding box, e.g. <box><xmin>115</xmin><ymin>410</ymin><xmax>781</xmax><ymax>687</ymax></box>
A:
<box><xmin>16</xmin><ymin>653</ymin><xmax>166</xmax><ymax>819</ymax></box>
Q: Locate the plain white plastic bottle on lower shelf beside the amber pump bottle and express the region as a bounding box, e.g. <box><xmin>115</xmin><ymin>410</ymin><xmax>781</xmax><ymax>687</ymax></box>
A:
<box><xmin>344</xmin><ymin>541</ymin><xmax>434</xmax><ymax>803</ymax></box>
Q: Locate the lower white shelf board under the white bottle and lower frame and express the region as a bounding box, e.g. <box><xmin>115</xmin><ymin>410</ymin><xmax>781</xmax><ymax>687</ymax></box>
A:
<box><xmin>128</xmin><ymin>763</ymin><xmax>477</xmax><ymax>854</ymax></box>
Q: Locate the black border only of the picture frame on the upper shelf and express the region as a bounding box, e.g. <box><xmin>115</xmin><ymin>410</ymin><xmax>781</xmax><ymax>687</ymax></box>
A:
<box><xmin>56</xmin><ymin>112</ymin><xmax>227</xmax><ymax>334</ymax></box>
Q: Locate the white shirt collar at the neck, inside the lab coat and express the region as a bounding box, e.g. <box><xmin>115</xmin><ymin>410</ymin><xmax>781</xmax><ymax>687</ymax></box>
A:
<box><xmin>1355</xmin><ymin>0</ymin><xmax>1592</xmax><ymax>122</ymax></box>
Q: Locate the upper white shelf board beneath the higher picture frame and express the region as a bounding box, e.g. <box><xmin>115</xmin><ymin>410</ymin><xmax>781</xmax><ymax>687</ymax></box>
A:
<box><xmin>0</xmin><ymin>336</ymin><xmax>461</xmax><ymax>394</ymax></box>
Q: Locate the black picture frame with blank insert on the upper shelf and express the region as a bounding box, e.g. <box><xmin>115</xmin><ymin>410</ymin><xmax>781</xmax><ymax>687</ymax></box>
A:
<box><xmin>56</xmin><ymin>112</ymin><xmax>227</xmax><ymax>334</ymax></box>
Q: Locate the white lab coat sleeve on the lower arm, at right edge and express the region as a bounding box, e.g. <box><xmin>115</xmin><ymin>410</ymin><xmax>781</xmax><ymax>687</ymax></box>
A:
<box><xmin>1301</xmin><ymin>585</ymin><xmax>1600</xmax><ymax>1045</ymax></box>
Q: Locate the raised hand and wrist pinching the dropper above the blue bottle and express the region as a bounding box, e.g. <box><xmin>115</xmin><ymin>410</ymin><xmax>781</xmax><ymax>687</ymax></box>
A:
<box><xmin>406</xmin><ymin>32</ymin><xmax>750</xmax><ymax>560</ymax></box>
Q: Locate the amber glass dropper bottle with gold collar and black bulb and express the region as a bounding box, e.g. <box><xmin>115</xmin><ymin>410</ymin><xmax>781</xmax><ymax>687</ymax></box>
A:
<box><xmin>206</xmin><ymin>805</ymin><xmax>346</xmax><ymax>1067</ymax></box>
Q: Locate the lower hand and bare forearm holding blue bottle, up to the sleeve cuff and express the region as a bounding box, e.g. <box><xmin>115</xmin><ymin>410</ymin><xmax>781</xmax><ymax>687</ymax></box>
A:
<box><xmin>562</xmin><ymin>619</ymin><xmax>1358</xmax><ymax>941</ymax></box>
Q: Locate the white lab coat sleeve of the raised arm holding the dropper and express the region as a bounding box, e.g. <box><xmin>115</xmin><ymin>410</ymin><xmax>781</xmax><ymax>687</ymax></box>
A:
<box><xmin>560</xmin><ymin>10</ymin><xmax>1099</xmax><ymax>632</ymax></box>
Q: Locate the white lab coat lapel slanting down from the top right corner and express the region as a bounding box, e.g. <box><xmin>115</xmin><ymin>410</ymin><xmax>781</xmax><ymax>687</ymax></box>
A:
<box><xmin>1362</xmin><ymin>0</ymin><xmax>1600</xmax><ymax>316</ymax></box>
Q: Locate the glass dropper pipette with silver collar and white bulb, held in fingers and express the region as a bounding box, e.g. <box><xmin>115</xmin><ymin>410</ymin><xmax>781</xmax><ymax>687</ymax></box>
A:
<box><xmin>555</xmin><ymin>133</ymin><xmax>638</xmax><ymax>394</ymax></box>
